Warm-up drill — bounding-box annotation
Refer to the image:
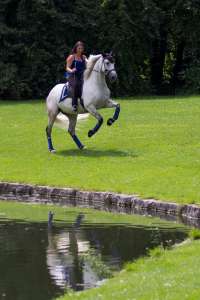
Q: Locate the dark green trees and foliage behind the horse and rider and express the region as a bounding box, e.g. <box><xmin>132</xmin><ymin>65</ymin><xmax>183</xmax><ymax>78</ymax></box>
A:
<box><xmin>0</xmin><ymin>0</ymin><xmax>200</xmax><ymax>99</ymax></box>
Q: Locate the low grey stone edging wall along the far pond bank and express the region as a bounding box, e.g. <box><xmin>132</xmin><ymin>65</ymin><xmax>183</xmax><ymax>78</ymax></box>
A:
<box><xmin>0</xmin><ymin>182</ymin><xmax>200</xmax><ymax>223</ymax></box>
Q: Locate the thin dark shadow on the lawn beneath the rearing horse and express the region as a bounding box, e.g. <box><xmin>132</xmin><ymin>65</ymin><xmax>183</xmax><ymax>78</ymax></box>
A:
<box><xmin>56</xmin><ymin>149</ymin><xmax>138</xmax><ymax>157</ymax></box>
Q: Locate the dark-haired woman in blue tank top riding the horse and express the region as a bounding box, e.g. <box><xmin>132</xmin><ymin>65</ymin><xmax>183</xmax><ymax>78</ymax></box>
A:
<box><xmin>66</xmin><ymin>41</ymin><xmax>87</xmax><ymax>111</ymax></box>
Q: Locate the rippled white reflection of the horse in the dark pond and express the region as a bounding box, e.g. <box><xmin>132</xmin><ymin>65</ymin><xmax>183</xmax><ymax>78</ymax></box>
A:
<box><xmin>47</xmin><ymin>229</ymin><xmax>99</xmax><ymax>290</ymax></box>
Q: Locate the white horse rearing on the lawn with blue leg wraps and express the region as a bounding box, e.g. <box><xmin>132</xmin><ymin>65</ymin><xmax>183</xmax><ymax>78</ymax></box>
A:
<box><xmin>46</xmin><ymin>54</ymin><xmax>120</xmax><ymax>152</ymax></box>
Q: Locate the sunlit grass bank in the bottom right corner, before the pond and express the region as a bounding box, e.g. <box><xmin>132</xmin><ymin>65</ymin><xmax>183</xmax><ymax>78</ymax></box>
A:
<box><xmin>59</xmin><ymin>241</ymin><xmax>200</xmax><ymax>300</ymax></box>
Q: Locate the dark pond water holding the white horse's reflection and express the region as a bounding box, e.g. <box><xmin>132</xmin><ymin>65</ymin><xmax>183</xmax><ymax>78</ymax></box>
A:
<box><xmin>0</xmin><ymin>217</ymin><xmax>187</xmax><ymax>300</ymax></box>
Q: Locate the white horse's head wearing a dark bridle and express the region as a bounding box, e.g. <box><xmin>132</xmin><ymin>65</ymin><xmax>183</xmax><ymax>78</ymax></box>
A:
<box><xmin>101</xmin><ymin>52</ymin><xmax>117</xmax><ymax>82</ymax></box>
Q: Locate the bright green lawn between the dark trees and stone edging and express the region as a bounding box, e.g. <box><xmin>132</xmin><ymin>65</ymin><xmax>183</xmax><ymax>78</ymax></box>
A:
<box><xmin>0</xmin><ymin>97</ymin><xmax>200</xmax><ymax>203</ymax></box>
